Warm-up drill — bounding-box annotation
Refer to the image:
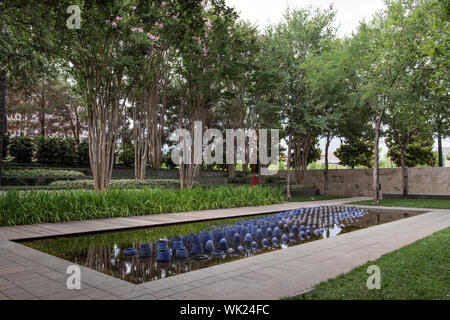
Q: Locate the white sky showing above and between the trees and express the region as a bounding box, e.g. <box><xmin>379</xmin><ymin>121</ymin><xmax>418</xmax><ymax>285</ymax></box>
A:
<box><xmin>225</xmin><ymin>0</ymin><xmax>450</xmax><ymax>157</ymax></box>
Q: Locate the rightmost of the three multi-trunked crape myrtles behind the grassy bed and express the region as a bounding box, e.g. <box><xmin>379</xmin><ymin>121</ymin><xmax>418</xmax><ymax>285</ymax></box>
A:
<box><xmin>175</xmin><ymin>1</ymin><xmax>236</xmax><ymax>188</ymax></box>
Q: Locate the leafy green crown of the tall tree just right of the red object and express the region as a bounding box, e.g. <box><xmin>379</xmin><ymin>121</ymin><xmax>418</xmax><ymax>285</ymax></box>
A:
<box><xmin>258</xmin><ymin>8</ymin><xmax>335</xmax><ymax>168</ymax></box>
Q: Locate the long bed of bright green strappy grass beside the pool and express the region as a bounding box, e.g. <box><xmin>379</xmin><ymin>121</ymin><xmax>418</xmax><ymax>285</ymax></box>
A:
<box><xmin>0</xmin><ymin>186</ymin><xmax>284</xmax><ymax>226</ymax></box>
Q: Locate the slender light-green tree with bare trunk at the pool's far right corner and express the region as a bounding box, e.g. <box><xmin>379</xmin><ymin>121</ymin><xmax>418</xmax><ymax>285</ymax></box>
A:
<box><xmin>349</xmin><ymin>12</ymin><xmax>404</xmax><ymax>205</ymax></box>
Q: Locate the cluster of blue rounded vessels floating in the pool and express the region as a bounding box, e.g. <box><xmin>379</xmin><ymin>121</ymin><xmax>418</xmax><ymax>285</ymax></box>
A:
<box><xmin>123</xmin><ymin>206</ymin><xmax>368</xmax><ymax>261</ymax></box>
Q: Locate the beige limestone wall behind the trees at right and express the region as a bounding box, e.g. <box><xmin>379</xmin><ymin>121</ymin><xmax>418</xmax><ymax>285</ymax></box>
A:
<box><xmin>278</xmin><ymin>167</ymin><xmax>450</xmax><ymax>197</ymax></box>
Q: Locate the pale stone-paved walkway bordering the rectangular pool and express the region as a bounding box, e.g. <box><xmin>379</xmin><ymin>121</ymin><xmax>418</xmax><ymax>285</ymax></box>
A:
<box><xmin>0</xmin><ymin>199</ymin><xmax>450</xmax><ymax>300</ymax></box>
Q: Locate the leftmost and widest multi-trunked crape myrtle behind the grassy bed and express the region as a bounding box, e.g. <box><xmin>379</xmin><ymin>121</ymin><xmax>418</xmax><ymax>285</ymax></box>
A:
<box><xmin>16</xmin><ymin>0</ymin><xmax>139</xmax><ymax>191</ymax></box>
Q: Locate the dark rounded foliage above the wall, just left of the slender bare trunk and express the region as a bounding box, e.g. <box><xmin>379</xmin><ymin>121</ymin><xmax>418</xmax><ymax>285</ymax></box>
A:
<box><xmin>334</xmin><ymin>139</ymin><xmax>373</xmax><ymax>168</ymax></box>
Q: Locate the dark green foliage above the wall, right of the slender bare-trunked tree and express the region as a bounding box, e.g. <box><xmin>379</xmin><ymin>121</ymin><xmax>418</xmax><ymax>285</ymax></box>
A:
<box><xmin>386</xmin><ymin>131</ymin><xmax>437</xmax><ymax>168</ymax></box>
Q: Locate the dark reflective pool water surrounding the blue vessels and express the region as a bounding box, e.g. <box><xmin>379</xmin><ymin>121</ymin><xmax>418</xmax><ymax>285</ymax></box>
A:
<box><xmin>23</xmin><ymin>211</ymin><xmax>417</xmax><ymax>283</ymax></box>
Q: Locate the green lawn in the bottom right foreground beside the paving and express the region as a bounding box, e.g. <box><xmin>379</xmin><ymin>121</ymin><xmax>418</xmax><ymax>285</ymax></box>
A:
<box><xmin>288</xmin><ymin>228</ymin><xmax>450</xmax><ymax>300</ymax></box>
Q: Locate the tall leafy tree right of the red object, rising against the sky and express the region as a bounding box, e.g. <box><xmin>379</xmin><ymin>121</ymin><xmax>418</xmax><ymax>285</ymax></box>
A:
<box><xmin>263</xmin><ymin>8</ymin><xmax>335</xmax><ymax>197</ymax></box>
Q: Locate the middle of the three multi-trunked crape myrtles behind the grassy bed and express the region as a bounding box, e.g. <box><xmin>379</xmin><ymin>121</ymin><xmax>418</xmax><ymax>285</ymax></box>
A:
<box><xmin>126</xmin><ymin>1</ymin><xmax>179</xmax><ymax>180</ymax></box>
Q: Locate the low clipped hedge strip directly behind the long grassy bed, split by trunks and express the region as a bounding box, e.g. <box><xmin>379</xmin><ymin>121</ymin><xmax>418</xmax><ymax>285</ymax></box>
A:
<box><xmin>50</xmin><ymin>179</ymin><xmax>185</xmax><ymax>189</ymax></box>
